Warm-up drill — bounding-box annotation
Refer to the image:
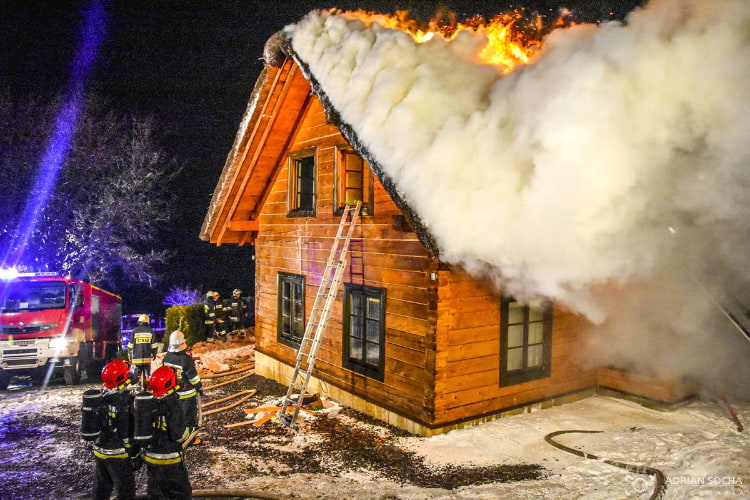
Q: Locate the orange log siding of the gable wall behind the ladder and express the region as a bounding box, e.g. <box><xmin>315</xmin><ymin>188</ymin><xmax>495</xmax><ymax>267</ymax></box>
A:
<box><xmin>255</xmin><ymin>99</ymin><xmax>437</xmax><ymax>425</ymax></box>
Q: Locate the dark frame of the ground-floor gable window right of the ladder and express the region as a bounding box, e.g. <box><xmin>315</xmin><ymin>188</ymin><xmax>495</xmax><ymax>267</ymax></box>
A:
<box><xmin>342</xmin><ymin>283</ymin><xmax>386</xmax><ymax>382</ymax></box>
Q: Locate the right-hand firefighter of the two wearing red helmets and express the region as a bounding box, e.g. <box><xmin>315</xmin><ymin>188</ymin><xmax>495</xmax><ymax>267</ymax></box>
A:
<box><xmin>143</xmin><ymin>366</ymin><xmax>193</xmax><ymax>500</ymax></box>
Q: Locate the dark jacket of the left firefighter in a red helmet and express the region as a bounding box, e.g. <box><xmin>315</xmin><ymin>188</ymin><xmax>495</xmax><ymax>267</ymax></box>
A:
<box><xmin>94</xmin><ymin>389</ymin><xmax>138</xmax><ymax>459</ymax></box>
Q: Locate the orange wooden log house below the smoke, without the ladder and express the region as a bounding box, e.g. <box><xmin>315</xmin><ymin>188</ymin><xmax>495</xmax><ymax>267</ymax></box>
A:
<box><xmin>200</xmin><ymin>33</ymin><xmax>684</xmax><ymax>436</ymax></box>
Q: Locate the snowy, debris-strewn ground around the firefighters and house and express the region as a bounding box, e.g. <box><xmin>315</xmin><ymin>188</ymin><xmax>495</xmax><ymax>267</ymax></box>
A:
<box><xmin>0</xmin><ymin>345</ymin><xmax>750</xmax><ymax>500</ymax></box>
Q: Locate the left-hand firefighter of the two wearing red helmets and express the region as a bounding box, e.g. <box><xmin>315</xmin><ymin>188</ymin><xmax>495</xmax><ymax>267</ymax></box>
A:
<box><xmin>88</xmin><ymin>359</ymin><xmax>141</xmax><ymax>500</ymax></box>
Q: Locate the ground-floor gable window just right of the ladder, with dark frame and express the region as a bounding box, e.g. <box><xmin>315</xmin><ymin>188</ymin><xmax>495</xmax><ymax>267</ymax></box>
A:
<box><xmin>343</xmin><ymin>283</ymin><xmax>385</xmax><ymax>381</ymax></box>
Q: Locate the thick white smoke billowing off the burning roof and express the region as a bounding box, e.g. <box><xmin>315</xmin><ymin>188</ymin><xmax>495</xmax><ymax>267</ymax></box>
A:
<box><xmin>286</xmin><ymin>0</ymin><xmax>750</xmax><ymax>394</ymax></box>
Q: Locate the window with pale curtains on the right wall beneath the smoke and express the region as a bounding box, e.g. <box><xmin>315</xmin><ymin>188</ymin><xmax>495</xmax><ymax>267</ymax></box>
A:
<box><xmin>500</xmin><ymin>297</ymin><xmax>552</xmax><ymax>386</ymax></box>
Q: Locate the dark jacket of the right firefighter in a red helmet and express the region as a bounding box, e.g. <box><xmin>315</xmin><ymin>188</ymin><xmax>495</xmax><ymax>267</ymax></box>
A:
<box><xmin>143</xmin><ymin>393</ymin><xmax>190</xmax><ymax>465</ymax></box>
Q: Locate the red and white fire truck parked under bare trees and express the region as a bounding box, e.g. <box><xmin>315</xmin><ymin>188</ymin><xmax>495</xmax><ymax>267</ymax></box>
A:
<box><xmin>0</xmin><ymin>273</ymin><xmax>122</xmax><ymax>390</ymax></box>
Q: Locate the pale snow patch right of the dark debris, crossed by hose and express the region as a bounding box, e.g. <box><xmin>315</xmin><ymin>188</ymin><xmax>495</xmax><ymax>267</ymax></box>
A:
<box><xmin>402</xmin><ymin>397</ymin><xmax>750</xmax><ymax>499</ymax></box>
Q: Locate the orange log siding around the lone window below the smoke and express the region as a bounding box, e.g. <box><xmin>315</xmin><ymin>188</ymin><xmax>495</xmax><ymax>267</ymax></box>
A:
<box><xmin>433</xmin><ymin>268</ymin><xmax>596</xmax><ymax>426</ymax></box>
